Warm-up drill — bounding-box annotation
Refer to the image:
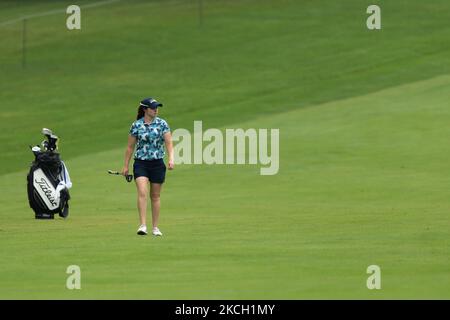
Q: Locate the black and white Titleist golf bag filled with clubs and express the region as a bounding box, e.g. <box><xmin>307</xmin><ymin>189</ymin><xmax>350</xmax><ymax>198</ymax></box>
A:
<box><xmin>27</xmin><ymin>128</ymin><xmax>72</xmax><ymax>219</ymax></box>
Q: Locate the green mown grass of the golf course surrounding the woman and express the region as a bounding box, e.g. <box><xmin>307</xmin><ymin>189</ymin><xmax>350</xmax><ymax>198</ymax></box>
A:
<box><xmin>0</xmin><ymin>0</ymin><xmax>450</xmax><ymax>299</ymax></box>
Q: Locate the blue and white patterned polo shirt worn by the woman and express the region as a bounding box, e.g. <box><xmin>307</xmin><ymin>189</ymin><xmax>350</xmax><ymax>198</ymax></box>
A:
<box><xmin>130</xmin><ymin>117</ymin><xmax>170</xmax><ymax>160</ymax></box>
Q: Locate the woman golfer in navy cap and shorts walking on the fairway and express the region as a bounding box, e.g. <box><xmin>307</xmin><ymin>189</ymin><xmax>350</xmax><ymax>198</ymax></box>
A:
<box><xmin>122</xmin><ymin>98</ymin><xmax>174</xmax><ymax>236</ymax></box>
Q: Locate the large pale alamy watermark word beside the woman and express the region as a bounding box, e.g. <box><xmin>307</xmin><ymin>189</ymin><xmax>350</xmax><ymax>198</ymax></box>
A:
<box><xmin>172</xmin><ymin>121</ymin><xmax>280</xmax><ymax>175</ymax></box>
